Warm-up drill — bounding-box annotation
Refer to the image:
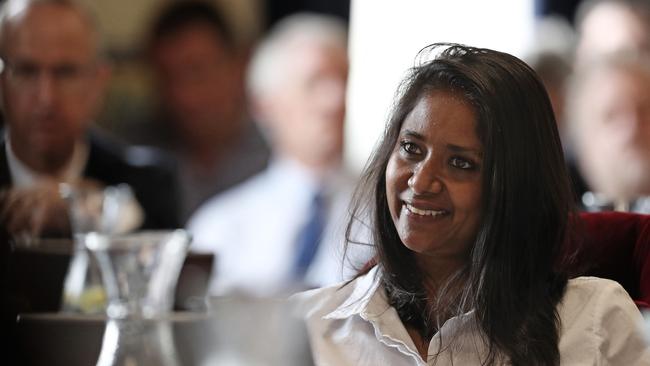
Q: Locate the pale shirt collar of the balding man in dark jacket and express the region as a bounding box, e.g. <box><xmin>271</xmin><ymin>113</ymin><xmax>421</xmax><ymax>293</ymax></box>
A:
<box><xmin>5</xmin><ymin>133</ymin><xmax>89</xmax><ymax>187</ymax></box>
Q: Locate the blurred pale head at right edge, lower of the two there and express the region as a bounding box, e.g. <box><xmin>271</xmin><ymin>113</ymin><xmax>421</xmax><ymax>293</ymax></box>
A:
<box><xmin>567</xmin><ymin>54</ymin><xmax>650</xmax><ymax>213</ymax></box>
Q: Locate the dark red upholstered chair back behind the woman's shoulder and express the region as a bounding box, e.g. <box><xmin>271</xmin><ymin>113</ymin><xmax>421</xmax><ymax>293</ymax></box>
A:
<box><xmin>574</xmin><ymin>212</ymin><xmax>650</xmax><ymax>308</ymax></box>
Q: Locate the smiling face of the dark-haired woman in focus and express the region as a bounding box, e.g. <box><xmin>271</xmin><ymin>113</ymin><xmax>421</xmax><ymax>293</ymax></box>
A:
<box><xmin>386</xmin><ymin>91</ymin><xmax>483</xmax><ymax>260</ymax></box>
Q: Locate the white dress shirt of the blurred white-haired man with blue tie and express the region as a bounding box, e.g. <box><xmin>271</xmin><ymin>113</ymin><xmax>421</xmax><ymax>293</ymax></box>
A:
<box><xmin>187</xmin><ymin>160</ymin><xmax>370</xmax><ymax>295</ymax></box>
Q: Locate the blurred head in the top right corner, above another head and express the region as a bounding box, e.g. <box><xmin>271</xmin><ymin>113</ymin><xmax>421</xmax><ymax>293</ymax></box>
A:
<box><xmin>575</xmin><ymin>0</ymin><xmax>650</xmax><ymax>68</ymax></box>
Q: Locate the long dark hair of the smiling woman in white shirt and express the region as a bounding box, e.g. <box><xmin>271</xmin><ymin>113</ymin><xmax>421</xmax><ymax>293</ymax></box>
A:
<box><xmin>347</xmin><ymin>44</ymin><xmax>574</xmax><ymax>365</ymax></box>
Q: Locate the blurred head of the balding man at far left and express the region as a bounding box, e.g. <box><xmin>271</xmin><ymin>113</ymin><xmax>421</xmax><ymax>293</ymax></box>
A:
<box><xmin>0</xmin><ymin>0</ymin><xmax>108</xmax><ymax>174</ymax></box>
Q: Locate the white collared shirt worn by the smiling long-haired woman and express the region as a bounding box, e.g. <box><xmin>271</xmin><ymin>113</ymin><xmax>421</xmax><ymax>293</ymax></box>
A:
<box><xmin>292</xmin><ymin>267</ymin><xmax>650</xmax><ymax>366</ymax></box>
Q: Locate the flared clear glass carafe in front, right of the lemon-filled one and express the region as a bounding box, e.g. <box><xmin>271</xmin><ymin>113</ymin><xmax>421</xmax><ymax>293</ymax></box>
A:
<box><xmin>81</xmin><ymin>230</ymin><xmax>189</xmax><ymax>366</ymax></box>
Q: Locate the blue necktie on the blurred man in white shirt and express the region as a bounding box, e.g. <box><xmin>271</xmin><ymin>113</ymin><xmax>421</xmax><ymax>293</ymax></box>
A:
<box><xmin>293</xmin><ymin>191</ymin><xmax>325</xmax><ymax>280</ymax></box>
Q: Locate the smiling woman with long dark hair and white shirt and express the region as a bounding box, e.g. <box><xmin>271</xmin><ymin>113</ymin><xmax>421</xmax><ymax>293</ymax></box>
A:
<box><xmin>296</xmin><ymin>44</ymin><xmax>650</xmax><ymax>366</ymax></box>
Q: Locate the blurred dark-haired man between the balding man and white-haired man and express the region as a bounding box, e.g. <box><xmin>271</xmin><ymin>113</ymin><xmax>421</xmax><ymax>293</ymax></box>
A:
<box><xmin>144</xmin><ymin>1</ymin><xmax>269</xmax><ymax>221</ymax></box>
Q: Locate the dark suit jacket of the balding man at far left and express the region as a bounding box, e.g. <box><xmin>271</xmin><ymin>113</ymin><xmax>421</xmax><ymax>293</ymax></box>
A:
<box><xmin>0</xmin><ymin>132</ymin><xmax>181</xmax><ymax>229</ymax></box>
